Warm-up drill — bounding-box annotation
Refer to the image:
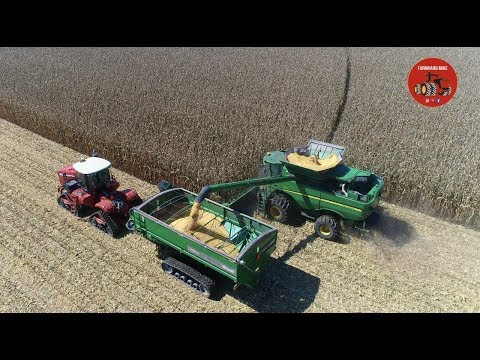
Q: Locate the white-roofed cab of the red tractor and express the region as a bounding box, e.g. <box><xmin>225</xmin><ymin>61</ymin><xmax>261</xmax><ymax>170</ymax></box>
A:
<box><xmin>72</xmin><ymin>157</ymin><xmax>111</xmax><ymax>193</ymax></box>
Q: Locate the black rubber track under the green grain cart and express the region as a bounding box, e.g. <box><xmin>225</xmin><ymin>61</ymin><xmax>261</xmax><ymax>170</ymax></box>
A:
<box><xmin>162</xmin><ymin>257</ymin><xmax>215</xmax><ymax>297</ymax></box>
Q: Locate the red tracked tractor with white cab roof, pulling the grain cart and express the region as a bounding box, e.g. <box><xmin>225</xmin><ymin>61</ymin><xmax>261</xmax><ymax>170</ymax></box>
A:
<box><xmin>57</xmin><ymin>151</ymin><xmax>142</xmax><ymax>237</ymax></box>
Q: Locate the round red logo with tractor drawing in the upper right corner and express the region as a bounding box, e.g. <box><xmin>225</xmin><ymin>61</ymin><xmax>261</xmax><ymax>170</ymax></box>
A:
<box><xmin>408</xmin><ymin>58</ymin><xmax>457</xmax><ymax>107</ymax></box>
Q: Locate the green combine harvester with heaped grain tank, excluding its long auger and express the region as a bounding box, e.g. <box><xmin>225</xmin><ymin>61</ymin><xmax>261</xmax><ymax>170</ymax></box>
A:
<box><xmin>257</xmin><ymin>140</ymin><xmax>384</xmax><ymax>239</ymax></box>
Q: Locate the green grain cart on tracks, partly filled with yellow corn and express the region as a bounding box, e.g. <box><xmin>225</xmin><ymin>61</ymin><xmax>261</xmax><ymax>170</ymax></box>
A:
<box><xmin>127</xmin><ymin>188</ymin><xmax>277</xmax><ymax>296</ymax></box>
